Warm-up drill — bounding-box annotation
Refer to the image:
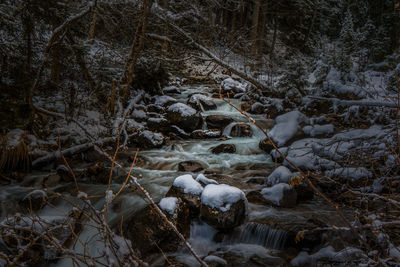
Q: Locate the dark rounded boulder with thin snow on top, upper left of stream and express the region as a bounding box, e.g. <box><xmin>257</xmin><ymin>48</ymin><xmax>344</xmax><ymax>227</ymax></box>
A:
<box><xmin>167</xmin><ymin>103</ymin><xmax>202</xmax><ymax>132</ymax></box>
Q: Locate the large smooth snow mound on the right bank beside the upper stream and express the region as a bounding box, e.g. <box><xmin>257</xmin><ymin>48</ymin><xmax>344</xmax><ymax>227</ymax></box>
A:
<box><xmin>270</xmin><ymin>111</ymin><xmax>308</xmax><ymax>146</ymax></box>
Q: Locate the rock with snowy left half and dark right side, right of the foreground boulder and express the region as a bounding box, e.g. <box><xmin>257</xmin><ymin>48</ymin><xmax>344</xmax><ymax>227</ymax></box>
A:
<box><xmin>261</xmin><ymin>183</ymin><xmax>297</xmax><ymax>208</ymax></box>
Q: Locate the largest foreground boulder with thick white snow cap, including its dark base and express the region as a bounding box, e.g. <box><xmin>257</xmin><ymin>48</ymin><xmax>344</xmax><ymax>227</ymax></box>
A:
<box><xmin>200</xmin><ymin>184</ymin><xmax>248</xmax><ymax>230</ymax></box>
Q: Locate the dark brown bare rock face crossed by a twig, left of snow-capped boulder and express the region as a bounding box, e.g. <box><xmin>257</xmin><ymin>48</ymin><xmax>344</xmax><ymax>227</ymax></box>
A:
<box><xmin>123</xmin><ymin>199</ymin><xmax>190</xmax><ymax>258</ymax></box>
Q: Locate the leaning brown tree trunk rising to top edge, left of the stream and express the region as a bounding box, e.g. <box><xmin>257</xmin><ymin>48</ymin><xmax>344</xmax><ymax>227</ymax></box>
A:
<box><xmin>122</xmin><ymin>0</ymin><xmax>153</xmax><ymax>101</ymax></box>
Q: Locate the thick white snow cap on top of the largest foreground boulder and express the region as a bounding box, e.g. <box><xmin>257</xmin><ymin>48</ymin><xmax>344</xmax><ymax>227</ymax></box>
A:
<box><xmin>201</xmin><ymin>184</ymin><xmax>247</xmax><ymax>212</ymax></box>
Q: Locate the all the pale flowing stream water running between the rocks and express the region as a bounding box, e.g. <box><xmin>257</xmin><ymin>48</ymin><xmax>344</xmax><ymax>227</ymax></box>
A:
<box><xmin>0</xmin><ymin>86</ymin><xmax>346</xmax><ymax>266</ymax></box>
